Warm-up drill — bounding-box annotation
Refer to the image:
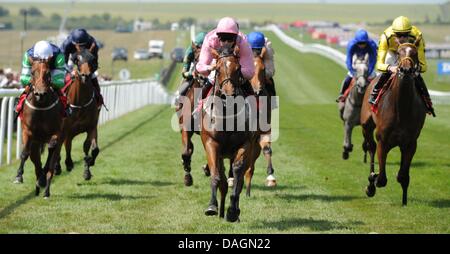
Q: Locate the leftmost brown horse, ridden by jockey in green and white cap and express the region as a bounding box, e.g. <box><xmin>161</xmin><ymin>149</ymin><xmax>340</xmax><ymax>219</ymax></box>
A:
<box><xmin>16</xmin><ymin>57</ymin><xmax>63</xmax><ymax>198</ymax></box>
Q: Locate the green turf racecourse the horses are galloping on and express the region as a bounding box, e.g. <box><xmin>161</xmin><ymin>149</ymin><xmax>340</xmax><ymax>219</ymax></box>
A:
<box><xmin>0</xmin><ymin>34</ymin><xmax>450</xmax><ymax>233</ymax></box>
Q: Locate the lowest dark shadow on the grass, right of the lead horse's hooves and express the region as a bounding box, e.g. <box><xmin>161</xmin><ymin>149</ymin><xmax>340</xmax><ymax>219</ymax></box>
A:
<box><xmin>252</xmin><ymin>218</ymin><xmax>364</xmax><ymax>231</ymax></box>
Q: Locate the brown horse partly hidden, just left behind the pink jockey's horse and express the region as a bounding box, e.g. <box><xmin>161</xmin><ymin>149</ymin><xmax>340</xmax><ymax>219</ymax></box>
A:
<box><xmin>177</xmin><ymin>43</ymin><xmax>210</xmax><ymax>186</ymax></box>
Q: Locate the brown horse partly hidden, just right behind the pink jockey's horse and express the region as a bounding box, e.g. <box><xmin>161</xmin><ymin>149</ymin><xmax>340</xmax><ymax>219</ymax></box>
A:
<box><xmin>241</xmin><ymin>48</ymin><xmax>276</xmax><ymax>196</ymax></box>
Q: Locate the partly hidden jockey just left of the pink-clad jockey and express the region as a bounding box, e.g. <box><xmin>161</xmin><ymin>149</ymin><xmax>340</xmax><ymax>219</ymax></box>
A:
<box><xmin>175</xmin><ymin>32</ymin><xmax>206</xmax><ymax>109</ymax></box>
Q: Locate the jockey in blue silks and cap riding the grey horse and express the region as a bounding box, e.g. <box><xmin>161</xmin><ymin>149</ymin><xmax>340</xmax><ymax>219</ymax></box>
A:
<box><xmin>336</xmin><ymin>29</ymin><xmax>377</xmax><ymax>102</ymax></box>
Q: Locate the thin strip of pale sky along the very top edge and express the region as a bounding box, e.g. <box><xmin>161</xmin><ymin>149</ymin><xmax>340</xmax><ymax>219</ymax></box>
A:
<box><xmin>0</xmin><ymin>0</ymin><xmax>446</xmax><ymax>4</ymax></box>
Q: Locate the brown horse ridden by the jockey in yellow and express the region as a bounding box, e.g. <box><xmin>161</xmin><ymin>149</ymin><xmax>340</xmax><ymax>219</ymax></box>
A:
<box><xmin>361</xmin><ymin>38</ymin><xmax>426</xmax><ymax>205</ymax></box>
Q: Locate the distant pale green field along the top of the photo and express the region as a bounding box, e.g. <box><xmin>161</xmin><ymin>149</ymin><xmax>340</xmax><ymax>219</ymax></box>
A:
<box><xmin>2</xmin><ymin>2</ymin><xmax>440</xmax><ymax>22</ymax></box>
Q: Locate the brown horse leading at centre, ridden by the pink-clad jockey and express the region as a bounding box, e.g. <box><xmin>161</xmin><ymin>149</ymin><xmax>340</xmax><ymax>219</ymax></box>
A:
<box><xmin>201</xmin><ymin>46</ymin><xmax>257</xmax><ymax>222</ymax></box>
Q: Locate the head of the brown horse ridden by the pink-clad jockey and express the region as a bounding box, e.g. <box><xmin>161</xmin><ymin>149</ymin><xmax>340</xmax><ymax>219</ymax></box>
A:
<box><xmin>211</xmin><ymin>46</ymin><xmax>241</xmax><ymax>96</ymax></box>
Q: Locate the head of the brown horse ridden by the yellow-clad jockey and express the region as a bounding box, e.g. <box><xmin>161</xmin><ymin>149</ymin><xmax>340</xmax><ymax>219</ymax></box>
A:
<box><xmin>397</xmin><ymin>36</ymin><xmax>421</xmax><ymax>76</ymax></box>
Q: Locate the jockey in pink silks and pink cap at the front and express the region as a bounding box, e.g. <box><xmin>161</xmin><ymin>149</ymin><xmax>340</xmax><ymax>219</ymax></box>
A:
<box><xmin>196</xmin><ymin>17</ymin><xmax>255</xmax><ymax>97</ymax></box>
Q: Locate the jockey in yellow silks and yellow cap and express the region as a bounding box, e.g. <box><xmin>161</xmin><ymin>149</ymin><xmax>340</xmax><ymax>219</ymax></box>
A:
<box><xmin>369</xmin><ymin>16</ymin><xmax>435</xmax><ymax>116</ymax></box>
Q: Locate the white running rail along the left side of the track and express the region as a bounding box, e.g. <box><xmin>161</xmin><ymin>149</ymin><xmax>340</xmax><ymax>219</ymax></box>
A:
<box><xmin>0</xmin><ymin>80</ymin><xmax>173</xmax><ymax>166</ymax></box>
